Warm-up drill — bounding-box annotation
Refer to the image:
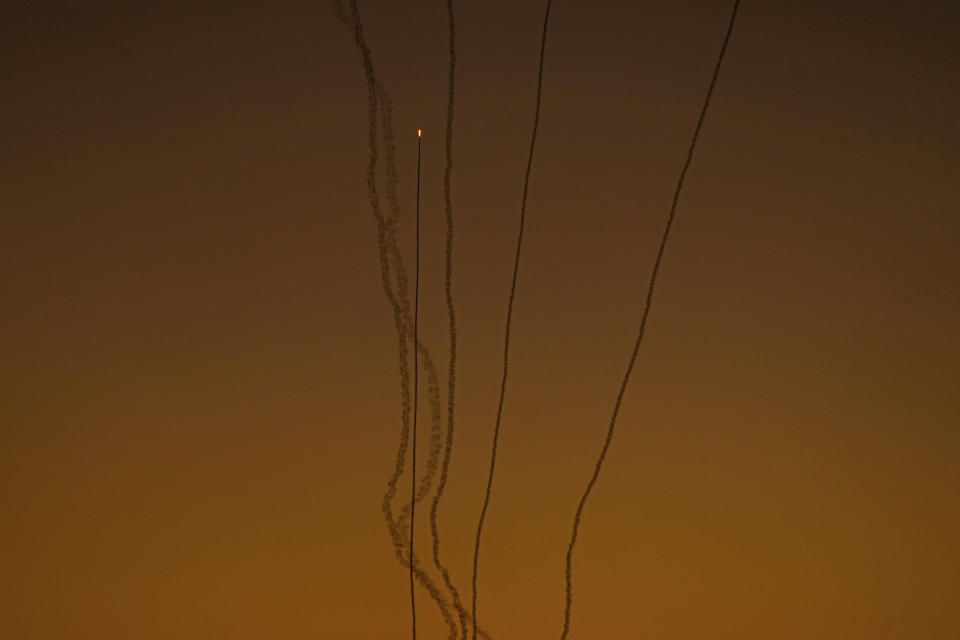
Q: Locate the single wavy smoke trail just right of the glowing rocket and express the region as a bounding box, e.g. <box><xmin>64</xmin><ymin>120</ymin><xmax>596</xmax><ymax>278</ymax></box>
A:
<box><xmin>430</xmin><ymin>0</ymin><xmax>475</xmax><ymax>640</ymax></box>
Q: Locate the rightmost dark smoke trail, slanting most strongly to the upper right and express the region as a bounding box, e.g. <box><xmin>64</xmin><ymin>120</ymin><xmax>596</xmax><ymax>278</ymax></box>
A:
<box><xmin>560</xmin><ymin>0</ymin><xmax>740</xmax><ymax>640</ymax></box>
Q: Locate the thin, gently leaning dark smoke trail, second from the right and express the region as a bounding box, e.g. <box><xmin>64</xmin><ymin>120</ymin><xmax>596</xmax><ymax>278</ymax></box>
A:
<box><xmin>471</xmin><ymin>0</ymin><xmax>553</xmax><ymax>640</ymax></box>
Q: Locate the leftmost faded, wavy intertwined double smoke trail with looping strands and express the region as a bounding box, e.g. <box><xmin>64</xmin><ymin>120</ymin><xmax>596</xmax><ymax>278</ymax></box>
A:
<box><xmin>332</xmin><ymin>0</ymin><xmax>490</xmax><ymax>640</ymax></box>
